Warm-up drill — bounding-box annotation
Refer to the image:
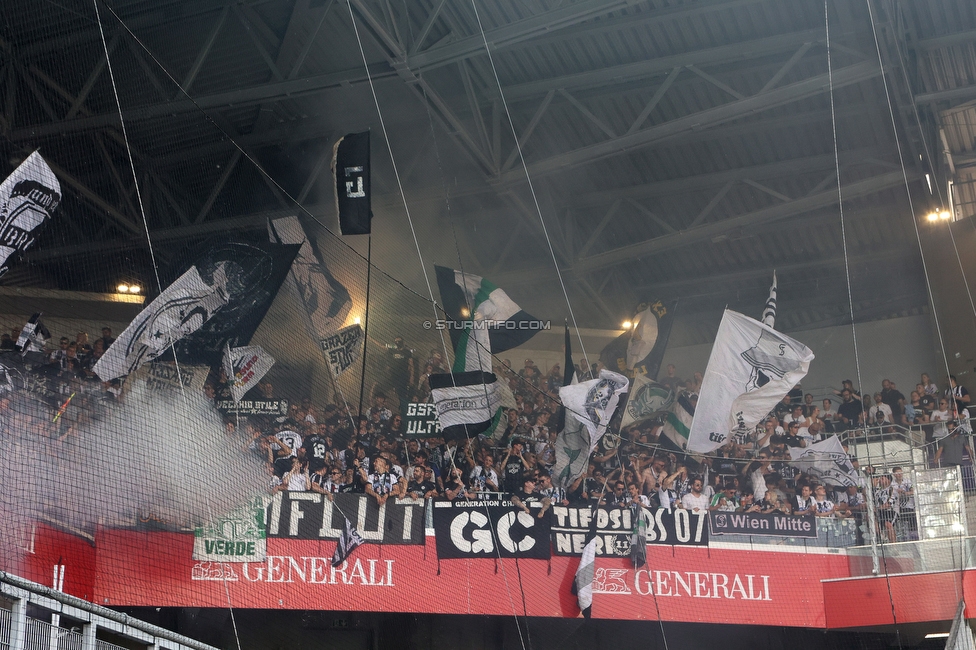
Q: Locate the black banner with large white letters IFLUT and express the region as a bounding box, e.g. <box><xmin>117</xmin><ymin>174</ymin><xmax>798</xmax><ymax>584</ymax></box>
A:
<box><xmin>267</xmin><ymin>492</ymin><xmax>424</xmax><ymax>544</ymax></box>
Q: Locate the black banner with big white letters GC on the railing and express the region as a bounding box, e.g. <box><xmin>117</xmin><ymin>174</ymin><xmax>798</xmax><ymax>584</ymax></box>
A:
<box><xmin>433</xmin><ymin>499</ymin><xmax>551</xmax><ymax>560</ymax></box>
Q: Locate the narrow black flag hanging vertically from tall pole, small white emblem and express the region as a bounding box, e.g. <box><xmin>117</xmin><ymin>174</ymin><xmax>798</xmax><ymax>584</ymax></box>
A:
<box><xmin>332</xmin><ymin>131</ymin><xmax>373</xmax><ymax>235</ymax></box>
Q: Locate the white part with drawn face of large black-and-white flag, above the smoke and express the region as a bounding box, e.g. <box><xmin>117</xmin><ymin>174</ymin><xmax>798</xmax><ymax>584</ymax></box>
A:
<box><xmin>93</xmin><ymin>265</ymin><xmax>228</xmax><ymax>381</ymax></box>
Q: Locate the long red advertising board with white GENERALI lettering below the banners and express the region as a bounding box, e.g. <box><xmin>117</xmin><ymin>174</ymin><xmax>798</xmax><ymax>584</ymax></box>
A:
<box><xmin>14</xmin><ymin>525</ymin><xmax>976</xmax><ymax>628</ymax></box>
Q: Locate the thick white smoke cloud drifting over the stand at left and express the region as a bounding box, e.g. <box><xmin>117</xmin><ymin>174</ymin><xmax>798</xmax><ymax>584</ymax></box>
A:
<box><xmin>0</xmin><ymin>368</ymin><xmax>268</xmax><ymax>568</ymax></box>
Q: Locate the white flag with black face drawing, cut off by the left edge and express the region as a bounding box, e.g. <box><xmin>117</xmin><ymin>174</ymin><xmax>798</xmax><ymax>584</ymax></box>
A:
<box><xmin>0</xmin><ymin>151</ymin><xmax>61</xmax><ymax>275</ymax></box>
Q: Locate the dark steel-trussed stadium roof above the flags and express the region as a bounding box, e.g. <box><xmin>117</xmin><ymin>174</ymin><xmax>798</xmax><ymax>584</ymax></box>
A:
<box><xmin>0</xmin><ymin>0</ymin><xmax>976</xmax><ymax>343</ymax></box>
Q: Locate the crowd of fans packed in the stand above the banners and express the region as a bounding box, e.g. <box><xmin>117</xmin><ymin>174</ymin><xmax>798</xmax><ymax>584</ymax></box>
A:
<box><xmin>9</xmin><ymin>328</ymin><xmax>972</xmax><ymax>541</ymax></box>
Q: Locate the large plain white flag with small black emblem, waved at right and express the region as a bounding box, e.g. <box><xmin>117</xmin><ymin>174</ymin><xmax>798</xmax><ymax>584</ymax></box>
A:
<box><xmin>688</xmin><ymin>309</ymin><xmax>814</xmax><ymax>453</ymax></box>
